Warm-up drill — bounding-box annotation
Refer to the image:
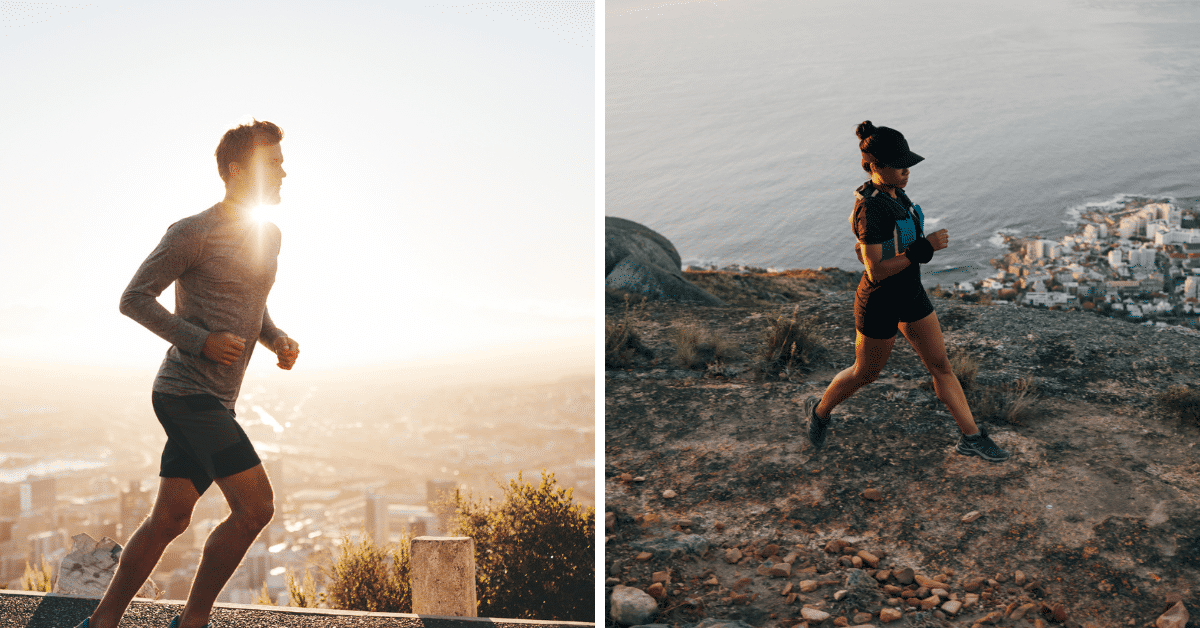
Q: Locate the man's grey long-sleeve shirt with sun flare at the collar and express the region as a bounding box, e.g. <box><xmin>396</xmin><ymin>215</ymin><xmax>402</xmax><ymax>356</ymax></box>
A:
<box><xmin>120</xmin><ymin>204</ymin><xmax>287</xmax><ymax>408</ymax></box>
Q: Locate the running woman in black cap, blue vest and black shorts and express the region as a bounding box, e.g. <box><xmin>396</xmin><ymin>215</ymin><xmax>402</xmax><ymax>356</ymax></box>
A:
<box><xmin>804</xmin><ymin>120</ymin><xmax>1009</xmax><ymax>462</ymax></box>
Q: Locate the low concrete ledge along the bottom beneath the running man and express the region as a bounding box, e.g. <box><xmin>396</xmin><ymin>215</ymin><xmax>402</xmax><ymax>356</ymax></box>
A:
<box><xmin>0</xmin><ymin>590</ymin><xmax>595</xmax><ymax>628</ymax></box>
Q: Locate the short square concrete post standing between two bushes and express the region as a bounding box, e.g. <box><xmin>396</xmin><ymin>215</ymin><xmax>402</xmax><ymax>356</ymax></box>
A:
<box><xmin>409</xmin><ymin>537</ymin><xmax>479</xmax><ymax>617</ymax></box>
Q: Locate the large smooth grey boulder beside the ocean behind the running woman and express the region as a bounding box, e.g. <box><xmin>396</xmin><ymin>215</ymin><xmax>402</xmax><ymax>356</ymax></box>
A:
<box><xmin>604</xmin><ymin>216</ymin><xmax>722</xmax><ymax>305</ymax></box>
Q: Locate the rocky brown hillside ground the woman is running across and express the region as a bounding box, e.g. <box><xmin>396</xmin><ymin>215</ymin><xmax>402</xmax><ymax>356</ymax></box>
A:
<box><xmin>605</xmin><ymin>269</ymin><xmax>1200</xmax><ymax>628</ymax></box>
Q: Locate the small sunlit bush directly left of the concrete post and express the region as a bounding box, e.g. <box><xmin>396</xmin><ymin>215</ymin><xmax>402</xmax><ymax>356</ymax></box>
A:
<box><xmin>324</xmin><ymin>533</ymin><xmax>413</xmax><ymax>612</ymax></box>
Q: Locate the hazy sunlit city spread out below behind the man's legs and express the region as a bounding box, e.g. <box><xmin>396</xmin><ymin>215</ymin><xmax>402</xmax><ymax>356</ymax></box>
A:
<box><xmin>0</xmin><ymin>371</ymin><xmax>595</xmax><ymax>604</ymax></box>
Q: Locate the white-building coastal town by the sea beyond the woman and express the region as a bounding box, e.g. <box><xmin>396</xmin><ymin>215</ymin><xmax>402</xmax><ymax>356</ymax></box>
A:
<box><xmin>930</xmin><ymin>199</ymin><xmax>1200</xmax><ymax>328</ymax></box>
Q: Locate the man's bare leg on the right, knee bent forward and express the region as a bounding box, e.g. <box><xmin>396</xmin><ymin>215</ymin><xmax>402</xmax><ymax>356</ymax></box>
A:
<box><xmin>179</xmin><ymin>465</ymin><xmax>275</xmax><ymax>628</ymax></box>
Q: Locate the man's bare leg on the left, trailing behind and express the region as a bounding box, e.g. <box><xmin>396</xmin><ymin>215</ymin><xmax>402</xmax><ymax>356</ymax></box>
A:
<box><xmin>88</xmin><ymin>478</ymin><xmax>200</xmax><ymax>628</ymax></box>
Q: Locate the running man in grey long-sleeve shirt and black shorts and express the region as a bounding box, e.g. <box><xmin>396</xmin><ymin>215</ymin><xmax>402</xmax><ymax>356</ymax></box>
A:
<box><xmin>79</xmin><ymin>120</ymin><xmax>300</xmax><ymax>628</ymax></box>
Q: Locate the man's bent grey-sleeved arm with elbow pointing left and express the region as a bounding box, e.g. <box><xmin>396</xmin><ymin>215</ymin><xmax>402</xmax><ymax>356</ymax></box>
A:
<box><xmin>120</xmin><ymin>223</ymin><xmax>209</xmax><ymax>354</ymax></box>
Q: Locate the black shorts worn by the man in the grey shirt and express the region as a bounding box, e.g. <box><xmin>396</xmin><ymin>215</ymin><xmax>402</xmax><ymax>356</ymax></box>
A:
<box><xmin>151</xmin><ymin>393</ymin><xmax>262</xmax><ymax>495</ymax></box>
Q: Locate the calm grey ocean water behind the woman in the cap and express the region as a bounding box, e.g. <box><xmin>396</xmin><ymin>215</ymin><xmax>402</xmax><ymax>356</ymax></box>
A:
<box><xmin>605</xmin><ymin>0</ymin><xmax>1200</xmax><ymax>285</ymax></box>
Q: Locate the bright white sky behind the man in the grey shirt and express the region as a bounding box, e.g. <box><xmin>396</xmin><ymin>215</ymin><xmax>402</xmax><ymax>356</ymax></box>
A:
<box><xmin>0</xmin><ymin>0</ymin><xmax>596</xmax><ymax>369</ymax></box>
